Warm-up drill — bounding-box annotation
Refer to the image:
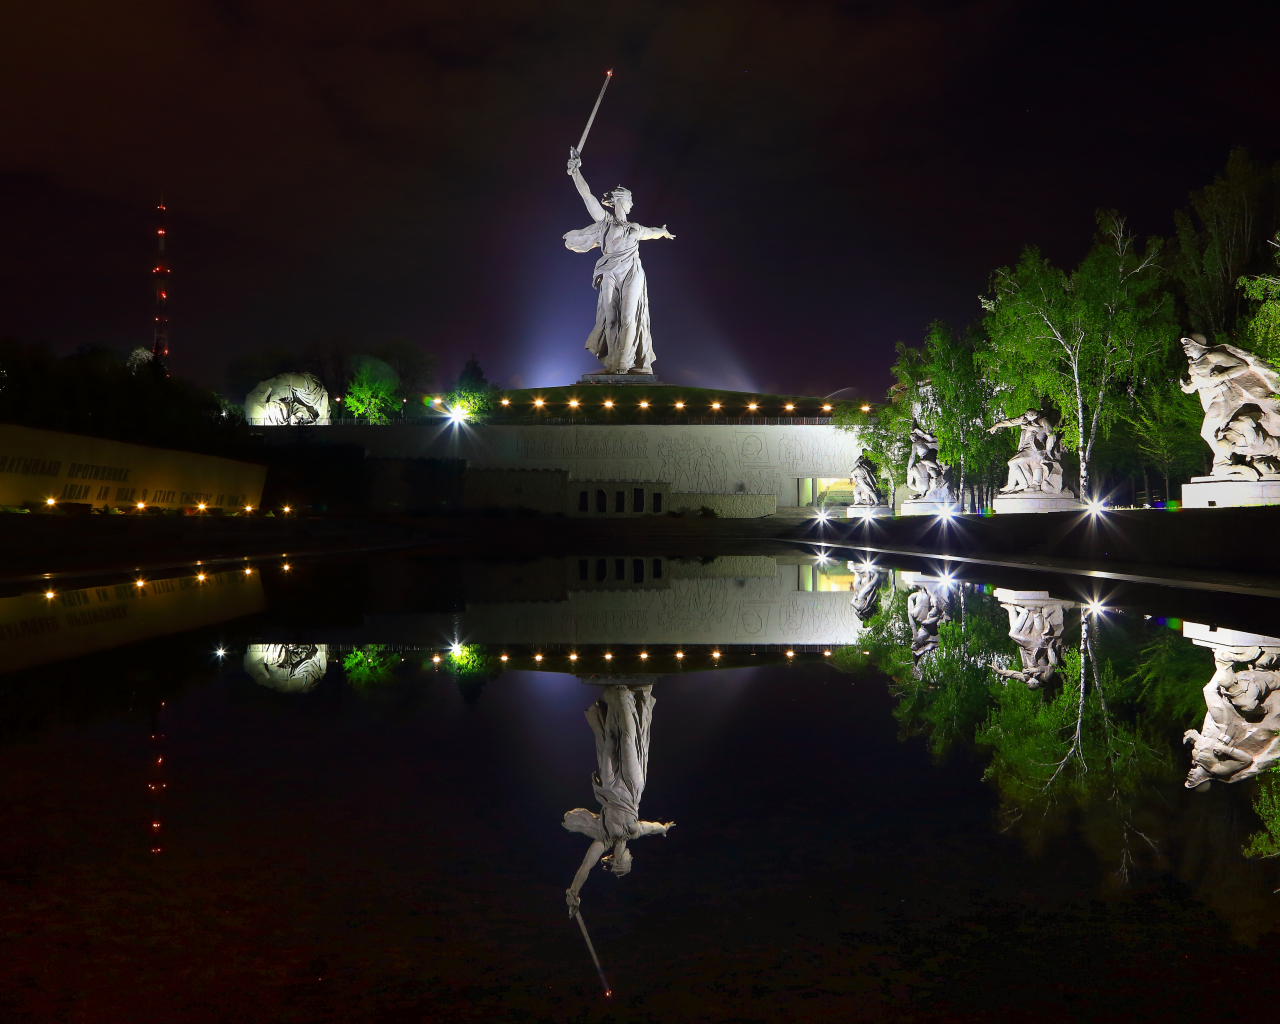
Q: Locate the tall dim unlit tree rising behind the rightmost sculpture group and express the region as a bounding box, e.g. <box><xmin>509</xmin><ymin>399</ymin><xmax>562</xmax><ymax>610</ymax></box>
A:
<box><xmin>1172</xmin><ymin>148</ymin><xmax>1275</xmax><ymax>340</ymax></box>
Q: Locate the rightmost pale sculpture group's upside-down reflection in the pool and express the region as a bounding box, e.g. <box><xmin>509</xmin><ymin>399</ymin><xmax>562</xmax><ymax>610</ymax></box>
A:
<box><xmin>1183</xmin><ymin>637</ymin><xmax>1280</xmax><ymax>788</ymax></box>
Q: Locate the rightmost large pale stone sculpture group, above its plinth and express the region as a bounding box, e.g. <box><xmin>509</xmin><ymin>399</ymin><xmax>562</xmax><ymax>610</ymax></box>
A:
<box><xmin>1180</xmin><ymin>334</ymin><xmax>1280</xmax><ymax>480</ymax></box>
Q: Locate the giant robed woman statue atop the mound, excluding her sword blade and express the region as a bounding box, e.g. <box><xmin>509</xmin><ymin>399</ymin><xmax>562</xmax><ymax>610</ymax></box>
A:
<box><xmin>564</xmin><ymin>150</ymin><xmax>676</xmax><ymax>374</ymax></box>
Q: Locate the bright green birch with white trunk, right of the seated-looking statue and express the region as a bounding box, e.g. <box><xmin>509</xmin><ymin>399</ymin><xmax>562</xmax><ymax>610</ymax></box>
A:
<box><xmin>979</xmin><ymin>210</ymin><xmax>1174</xmax><ymax>498</ymax></box>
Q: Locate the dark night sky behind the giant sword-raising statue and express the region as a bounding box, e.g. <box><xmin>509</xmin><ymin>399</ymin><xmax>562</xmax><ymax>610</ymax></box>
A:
<box><xmin>0</xmin><ymin>0</ymin><xmax>1280</xmax><ymax>396</ymax></box>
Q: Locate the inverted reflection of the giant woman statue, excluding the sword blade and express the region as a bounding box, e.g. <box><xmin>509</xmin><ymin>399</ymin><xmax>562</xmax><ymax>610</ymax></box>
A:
<box><xmin>564</xmin><ymin>685</ymin><xmax>675</xmax><ymax>918</ymax></box>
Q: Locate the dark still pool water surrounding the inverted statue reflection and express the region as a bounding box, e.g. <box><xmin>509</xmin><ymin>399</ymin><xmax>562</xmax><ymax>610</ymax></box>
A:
<box><xmin>0</xmin><ymin>556</ymin><xmax>1280</xmax><ymax>1021</ymax></box>
